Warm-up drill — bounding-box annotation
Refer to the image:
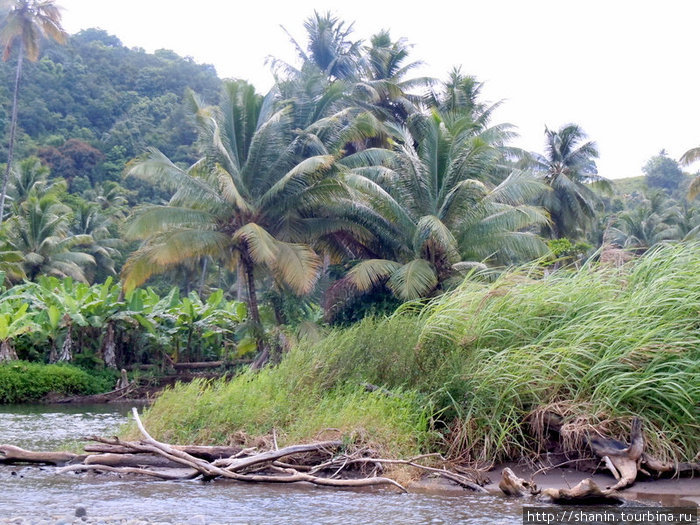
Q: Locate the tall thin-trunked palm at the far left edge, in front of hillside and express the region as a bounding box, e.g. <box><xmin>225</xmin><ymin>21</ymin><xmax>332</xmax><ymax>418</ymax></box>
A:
<box><xmin>0</xmin><ymin>0</ymin><xmax>66</xmax><ymax>221</ymax></box>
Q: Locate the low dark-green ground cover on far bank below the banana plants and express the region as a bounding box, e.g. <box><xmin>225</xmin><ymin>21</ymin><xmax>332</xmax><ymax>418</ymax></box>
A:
<box><xmin>0</xmin><ymin>361</ymin><xmax>115</xmax><ymax>404</ymax></box>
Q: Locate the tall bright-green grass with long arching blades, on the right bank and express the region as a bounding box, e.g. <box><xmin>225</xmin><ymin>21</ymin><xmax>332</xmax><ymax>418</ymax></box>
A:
<box><xmin>419</xmin><ymin>244</ymin><xmax>700</xmax><ymax>459</ymax></box>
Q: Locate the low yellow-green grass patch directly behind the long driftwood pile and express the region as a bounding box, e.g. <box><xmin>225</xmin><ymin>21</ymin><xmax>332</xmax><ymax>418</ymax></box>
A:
<box><xmin>136</xmin><ymin>369</ymin><xmax>428</xmax><ymax>455</ymax></box>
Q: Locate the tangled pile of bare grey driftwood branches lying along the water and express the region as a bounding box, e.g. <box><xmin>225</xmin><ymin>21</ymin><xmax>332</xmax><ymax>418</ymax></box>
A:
<box><xmin>0</xmin><ymin>408</ymin><xmax>485</xmax><ymax>492</ymax></box>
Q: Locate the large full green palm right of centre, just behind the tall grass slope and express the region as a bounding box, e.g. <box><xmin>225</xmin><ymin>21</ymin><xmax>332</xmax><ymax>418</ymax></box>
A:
<box><xmin>341</xmin><ymin>110</ymin><xmax>546</xmax><ymax>300</ymax></box>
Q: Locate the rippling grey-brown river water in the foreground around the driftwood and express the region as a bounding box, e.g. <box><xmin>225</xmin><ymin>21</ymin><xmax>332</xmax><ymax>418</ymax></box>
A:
<box><xmin>0</xmin><ymin>405</ymin><xmax>522</xmax><ymax>525</ymax></box>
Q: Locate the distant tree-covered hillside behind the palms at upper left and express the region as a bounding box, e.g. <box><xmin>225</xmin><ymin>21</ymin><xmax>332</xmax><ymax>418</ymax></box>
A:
<box><xmin>0</xmin><ymin>29</ymin><xmax>221</xmax><ymax>198</ymax></box>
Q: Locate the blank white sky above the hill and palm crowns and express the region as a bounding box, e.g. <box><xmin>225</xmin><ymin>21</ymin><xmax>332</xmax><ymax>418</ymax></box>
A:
<box><xmin>57</xmin><ymin>0</ymin><xmax>700</xmax><ymax>178</ymax></box>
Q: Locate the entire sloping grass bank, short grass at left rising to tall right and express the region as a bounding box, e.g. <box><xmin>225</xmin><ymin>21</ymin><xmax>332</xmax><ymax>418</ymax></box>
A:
<box><xmin>138</xmin><ymin>244</ymin><xmax>700</xmax><ymax>461</ymax></box>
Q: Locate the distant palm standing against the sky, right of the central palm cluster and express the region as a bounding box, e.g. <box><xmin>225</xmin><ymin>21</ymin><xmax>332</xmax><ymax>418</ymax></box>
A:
<box><xmin>532</xmin><ymin>124</ymin><xmax>611</xmax><ymax>238</ymax></box>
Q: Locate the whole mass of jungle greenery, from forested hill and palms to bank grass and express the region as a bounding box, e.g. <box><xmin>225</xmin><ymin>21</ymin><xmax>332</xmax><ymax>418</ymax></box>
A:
<box><xmin>0</xmin><ymin>5</ymin><xmax>700</xmax><ymax>466</ymax></box>
